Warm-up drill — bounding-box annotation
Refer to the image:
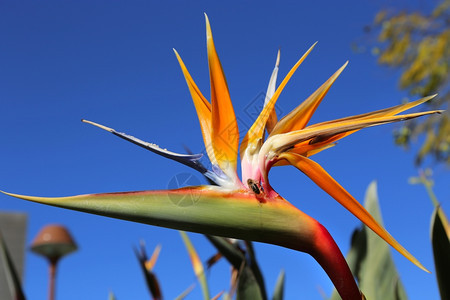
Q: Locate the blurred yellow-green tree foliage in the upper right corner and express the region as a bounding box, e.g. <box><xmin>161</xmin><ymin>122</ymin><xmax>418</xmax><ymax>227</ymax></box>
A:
<box><xmin>365</xmin><ymin>0</ymin><xmax>450</xmax><ymax>166</ymax></box>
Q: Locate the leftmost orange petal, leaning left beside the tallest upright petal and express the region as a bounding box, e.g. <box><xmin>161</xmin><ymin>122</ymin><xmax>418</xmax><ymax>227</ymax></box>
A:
<box><xmin>173</xmin><ymin>49</ymin><xmax>217</xmax><ymax>165</ymax></box>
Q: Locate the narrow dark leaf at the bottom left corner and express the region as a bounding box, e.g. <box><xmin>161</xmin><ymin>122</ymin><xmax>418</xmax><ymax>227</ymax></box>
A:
<box><xmin>0</xmin><ymin>232</ymin><xmax>26</xmax><ymax>300</ymax></box>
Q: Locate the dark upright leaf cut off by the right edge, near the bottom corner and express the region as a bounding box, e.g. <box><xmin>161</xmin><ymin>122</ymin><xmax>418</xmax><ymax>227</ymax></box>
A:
<box><xmin>431</xmin><ymin>206</ymin><xmax>450</xmax><ymax>299</ymax></box>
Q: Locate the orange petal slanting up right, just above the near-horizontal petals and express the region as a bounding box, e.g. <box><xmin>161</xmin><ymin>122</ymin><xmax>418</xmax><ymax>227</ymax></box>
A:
<box><xmin>272</xmin><ymin>62</ymin><xmax>348</xmax><ymax>135</ymax></box>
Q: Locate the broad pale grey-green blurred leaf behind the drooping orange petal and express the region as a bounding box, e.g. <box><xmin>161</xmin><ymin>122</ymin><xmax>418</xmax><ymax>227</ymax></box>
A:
<box><xmin>331</xmin><ymin>182</ymin><xmax>407</xmax><ymax>300</ymax></box>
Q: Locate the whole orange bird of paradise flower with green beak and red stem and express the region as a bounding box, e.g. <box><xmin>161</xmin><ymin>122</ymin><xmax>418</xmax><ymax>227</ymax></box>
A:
<box><xmin>4</xmin><ymin>15</ymin><xmax>441</xmax><ymax>299</ymax></box>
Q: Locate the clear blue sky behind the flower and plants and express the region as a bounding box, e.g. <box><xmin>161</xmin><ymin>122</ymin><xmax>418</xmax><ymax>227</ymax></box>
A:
<box><xmin>0</xmin><ymin>0</ymin><xmax>450</xmax><ymax>300</ymax></box>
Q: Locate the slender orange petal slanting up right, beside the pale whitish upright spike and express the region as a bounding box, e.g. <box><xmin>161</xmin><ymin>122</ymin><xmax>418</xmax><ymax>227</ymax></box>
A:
<box><xmin>240</xmin><ymin>42</ymin><xmax>317</xmax><ymax>155</ymax></box>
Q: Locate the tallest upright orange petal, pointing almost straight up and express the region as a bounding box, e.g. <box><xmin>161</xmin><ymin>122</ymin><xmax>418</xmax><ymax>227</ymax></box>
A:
<box><xmin>205</xmin><ymin>14</ymin><xmax>239</xmax><ymax>177</ymax></box>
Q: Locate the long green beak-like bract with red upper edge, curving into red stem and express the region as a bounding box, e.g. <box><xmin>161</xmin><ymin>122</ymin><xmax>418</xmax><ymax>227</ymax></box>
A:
<box><xmin>5</xmin><ymin>187</ymin><xmax>361</xmax><ymax>299</ymax></box>
